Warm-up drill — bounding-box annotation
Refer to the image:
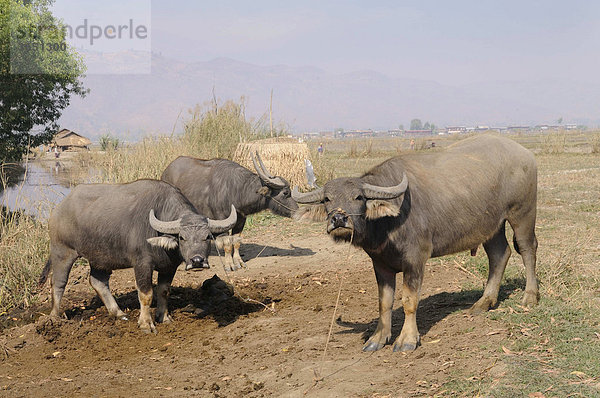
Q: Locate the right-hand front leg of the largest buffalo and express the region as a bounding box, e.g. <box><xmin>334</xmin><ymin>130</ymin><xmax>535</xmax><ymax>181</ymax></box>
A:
<box><xmin>394</xmin><ymin>264</ymin><xmax>424</xmax><ymax>352</ymax></box>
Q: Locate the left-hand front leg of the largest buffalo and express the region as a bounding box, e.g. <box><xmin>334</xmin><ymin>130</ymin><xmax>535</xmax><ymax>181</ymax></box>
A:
<box><xmin>363</xmin><ymin>262</ymin><xmax>396</xmax><ymax>351</ymax></box>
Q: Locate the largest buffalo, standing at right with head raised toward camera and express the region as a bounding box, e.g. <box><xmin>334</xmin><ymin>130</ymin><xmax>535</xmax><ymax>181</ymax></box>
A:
<box><xmin>292</xmin><ymin>135</ymin><xmax>538</xmax><ymax>351</ymax></box>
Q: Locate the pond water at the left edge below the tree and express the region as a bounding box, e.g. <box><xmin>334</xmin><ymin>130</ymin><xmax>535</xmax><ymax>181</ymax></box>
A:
<box><xmin>0</xmin><ymin>161</ymin><xmax>71</xmax><ymax>218</ymax></box>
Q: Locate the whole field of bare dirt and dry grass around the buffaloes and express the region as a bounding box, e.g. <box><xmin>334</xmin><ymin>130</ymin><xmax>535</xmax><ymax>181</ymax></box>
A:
<box><xmin>0</xmin><ymin>134</ymin><xmax>600</xmax><ymax>397</ymax></box>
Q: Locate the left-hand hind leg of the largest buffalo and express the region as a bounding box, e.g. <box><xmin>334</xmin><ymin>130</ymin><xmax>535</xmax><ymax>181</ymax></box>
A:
<box><xmin>469</xmin><ymin>224</ymin><xmax>510</xmax><ymax>314</ymax></box>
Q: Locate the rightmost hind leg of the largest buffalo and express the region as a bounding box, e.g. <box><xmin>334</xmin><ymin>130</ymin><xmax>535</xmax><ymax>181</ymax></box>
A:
<box><xmin>509</xmin><ymin>213</ymin><xmax>540</xmax><ymax>306</ymax></box>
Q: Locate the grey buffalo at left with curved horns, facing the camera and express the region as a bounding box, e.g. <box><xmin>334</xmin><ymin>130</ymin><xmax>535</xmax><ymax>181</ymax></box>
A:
<box><xmin>39</xmin><ymin>180</ymin><xmax>237</xmax><ymax>332</ymax></box>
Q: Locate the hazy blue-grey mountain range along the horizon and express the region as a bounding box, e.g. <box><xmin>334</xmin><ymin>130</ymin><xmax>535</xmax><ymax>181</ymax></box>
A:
<box><xmin>61</xmin><ymin>54</ymin><xmax>600</xmax><ymax>139</ymax></box>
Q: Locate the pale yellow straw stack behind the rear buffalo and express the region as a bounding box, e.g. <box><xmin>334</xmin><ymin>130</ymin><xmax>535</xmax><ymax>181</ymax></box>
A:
<box><xmin>233</xmin><ymin>137</ymin><xmax>310</xmax><ymax>189</ymax></box>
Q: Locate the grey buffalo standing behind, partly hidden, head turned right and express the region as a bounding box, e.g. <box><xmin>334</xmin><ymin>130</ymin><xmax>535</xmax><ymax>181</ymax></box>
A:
<box><xmin>161</xmin><ymin>152</ymin><xmax>298</xmax><ymax>271</ymax></box>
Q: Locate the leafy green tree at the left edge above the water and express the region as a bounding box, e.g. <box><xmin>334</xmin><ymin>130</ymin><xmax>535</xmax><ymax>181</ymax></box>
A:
<box><xmin>0</xmin><ymin>0</ymin><xmax>87</xmax><ymax>163</ymax></box>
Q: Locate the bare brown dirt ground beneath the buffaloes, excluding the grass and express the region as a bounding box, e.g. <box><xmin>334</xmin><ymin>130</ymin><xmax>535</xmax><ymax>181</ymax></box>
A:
<box><xmin>0</xmin><ymin>219</ymin><xmax>521</xmax><ymax>397</ymax></box>
